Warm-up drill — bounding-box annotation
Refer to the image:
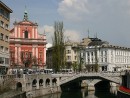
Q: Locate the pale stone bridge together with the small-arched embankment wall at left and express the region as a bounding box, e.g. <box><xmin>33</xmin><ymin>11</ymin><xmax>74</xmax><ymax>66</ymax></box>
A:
<box><xmin>0</xmin><ymin>73</ymin><xmax>121</xmax><ymax>96</ymax></box>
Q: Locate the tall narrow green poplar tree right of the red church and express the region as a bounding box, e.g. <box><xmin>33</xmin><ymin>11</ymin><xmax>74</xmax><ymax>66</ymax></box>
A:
<box><xmin>52</xmin><ymin>22</ymin><xmax>65</xmax><ymax>72</ymax></box>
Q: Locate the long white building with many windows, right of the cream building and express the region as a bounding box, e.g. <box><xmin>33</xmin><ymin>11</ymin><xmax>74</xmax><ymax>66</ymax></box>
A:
<box><xmin>84</xmin><ymin>40</ymin><xmax>130</xmax><ymax>71</ymax></box>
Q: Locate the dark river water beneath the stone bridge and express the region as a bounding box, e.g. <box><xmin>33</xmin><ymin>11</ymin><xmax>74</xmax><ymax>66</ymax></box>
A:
<box><xmin>37</xmin><ymin>87</ymin><xmax>117</xmax><ymax>98</ymax></box>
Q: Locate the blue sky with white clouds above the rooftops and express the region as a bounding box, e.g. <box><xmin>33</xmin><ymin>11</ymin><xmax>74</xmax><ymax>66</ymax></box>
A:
<box><xmin>2</xmin><ymin>0</ymin><xmax>130</xmax><ymax>47</ymax></box>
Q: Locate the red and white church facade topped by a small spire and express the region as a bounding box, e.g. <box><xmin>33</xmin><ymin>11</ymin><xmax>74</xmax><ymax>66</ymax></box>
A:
<box><xmin>10</xmin><ymin>11</ymin><xmax>47</xmax><ymax>68</ymax></box>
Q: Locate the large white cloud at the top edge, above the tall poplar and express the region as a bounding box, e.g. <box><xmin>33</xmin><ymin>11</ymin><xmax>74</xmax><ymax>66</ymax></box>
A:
<box><xmin>58</xmin><ymin>0</ymin><xmax>89</xmax><ymax>21</ymax></box>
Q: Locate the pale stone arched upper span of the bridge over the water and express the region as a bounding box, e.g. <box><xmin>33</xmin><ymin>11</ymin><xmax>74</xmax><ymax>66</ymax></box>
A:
<box><xmin>59</xmin><ymin>73</ymin><xmax>121</xmax><ymax>85</ymax></box>
